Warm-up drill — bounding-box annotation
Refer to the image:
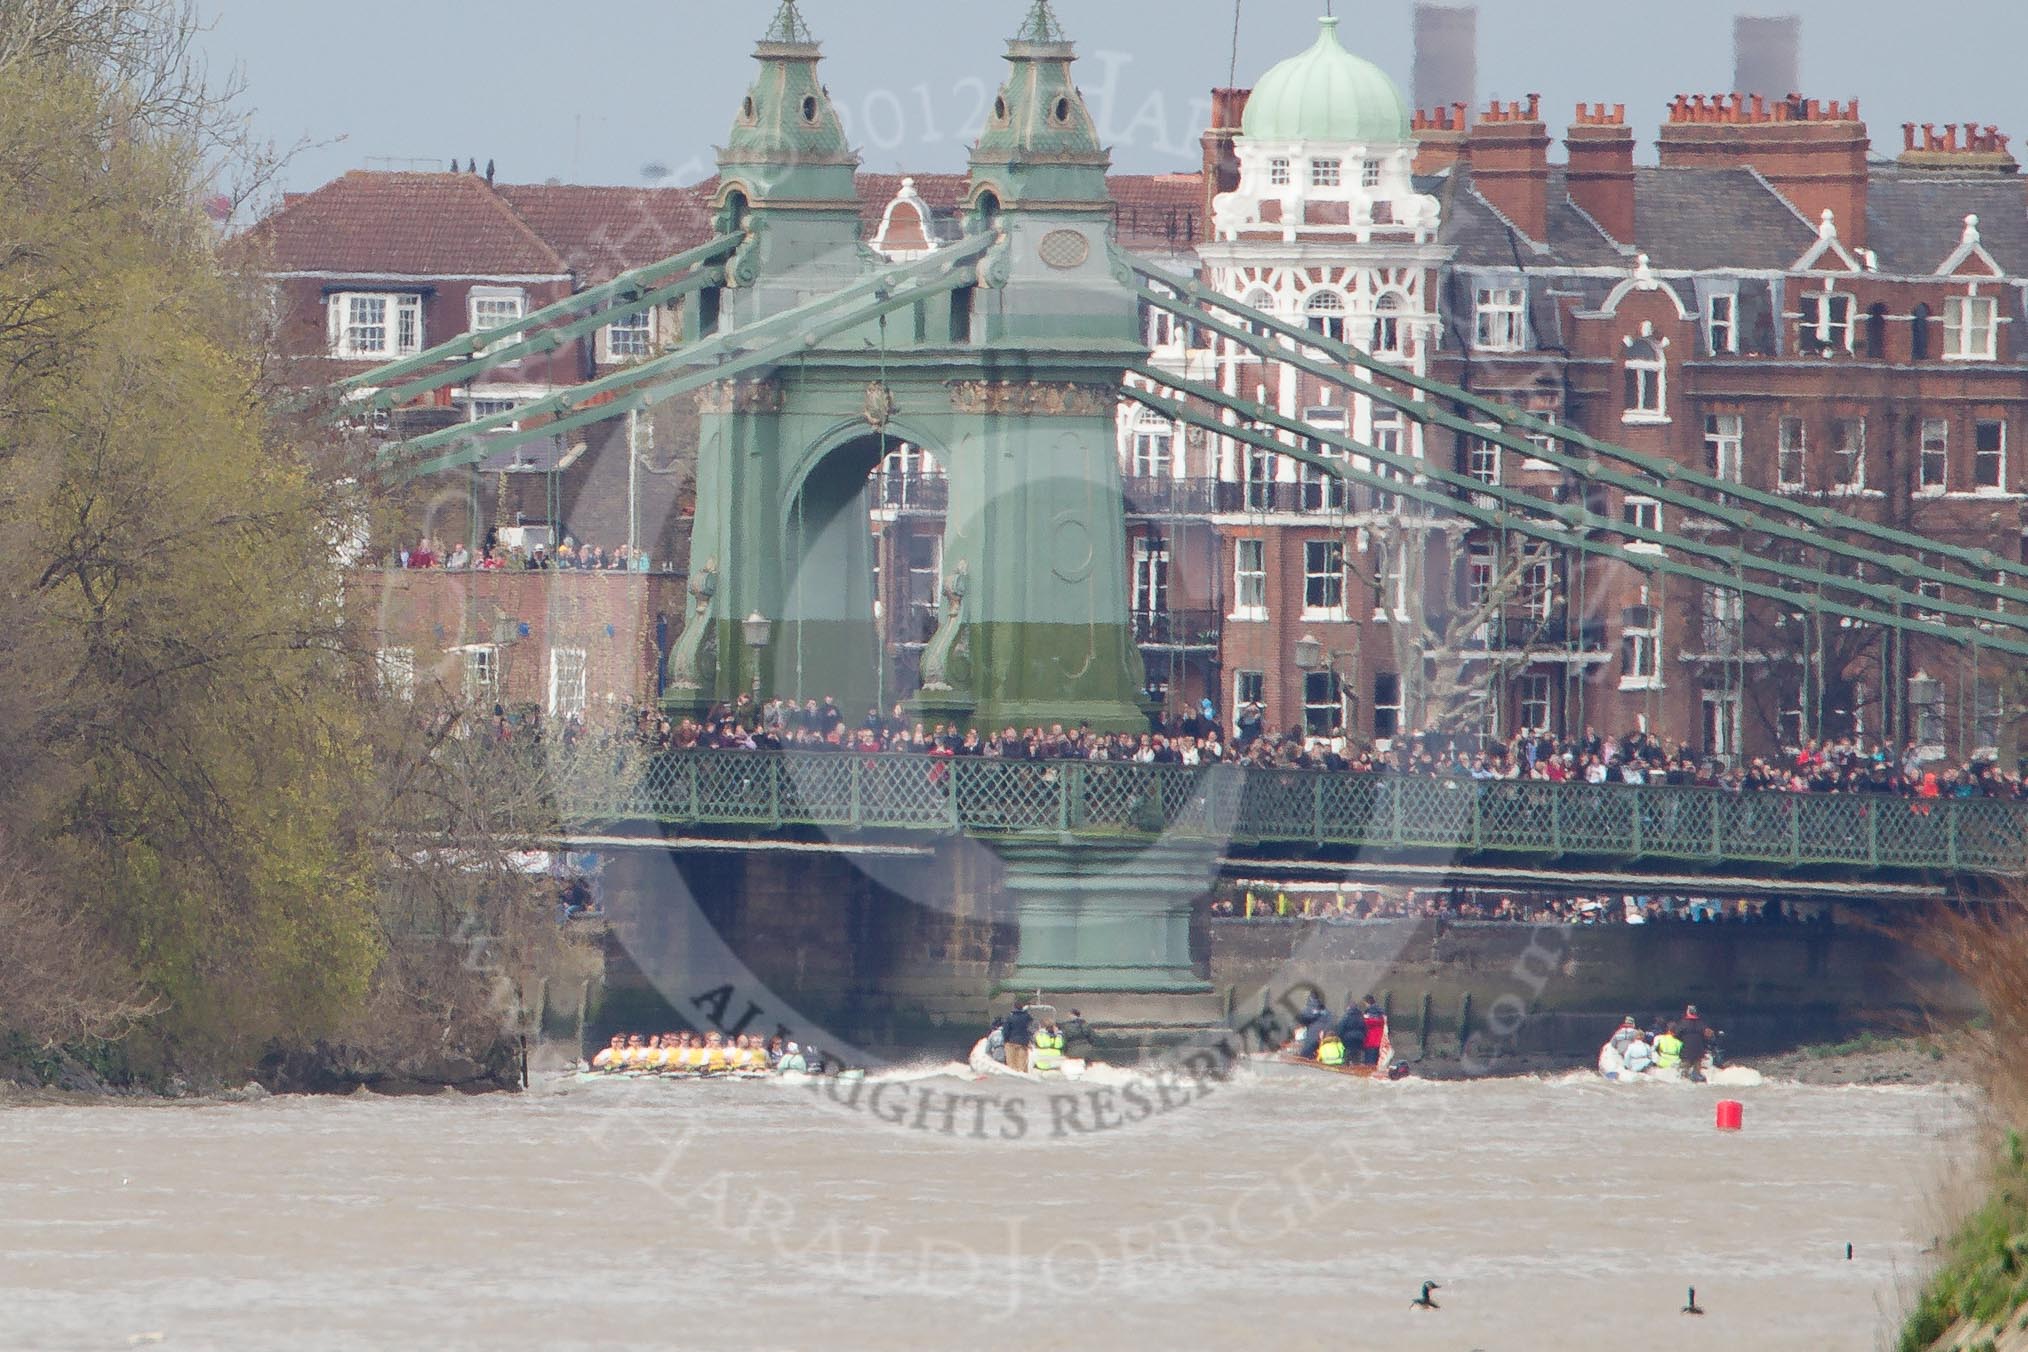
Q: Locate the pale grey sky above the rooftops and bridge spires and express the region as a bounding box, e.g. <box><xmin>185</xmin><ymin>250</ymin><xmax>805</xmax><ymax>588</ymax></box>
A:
<box><xmin>201</xmin><ymin>0</ymin><xmax>2028</xmax><ymax>189</ymax></box>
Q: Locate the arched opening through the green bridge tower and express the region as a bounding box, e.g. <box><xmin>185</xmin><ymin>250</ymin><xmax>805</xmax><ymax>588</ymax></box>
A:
<box><xmin>769</xmin><ymin>432</ymin><xmax>943</xmax><ymax>728</ymax></box>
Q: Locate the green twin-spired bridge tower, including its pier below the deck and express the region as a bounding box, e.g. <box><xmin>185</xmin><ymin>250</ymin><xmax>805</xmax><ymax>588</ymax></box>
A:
<box><xmin>667</xmin><ymin>0</ymin><xmax>1215</xmax><ymax>1032</ymax></box>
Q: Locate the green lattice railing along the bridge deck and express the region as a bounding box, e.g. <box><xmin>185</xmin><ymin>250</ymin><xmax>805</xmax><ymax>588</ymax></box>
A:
<box><xmin>543</xmin><ymin>750</ymin><xmax>2028</xmax><ymax>874</ymax></box>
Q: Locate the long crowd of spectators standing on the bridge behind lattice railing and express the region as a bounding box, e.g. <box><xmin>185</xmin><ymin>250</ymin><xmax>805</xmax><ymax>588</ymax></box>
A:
<box><xmin>604</xmin><ymin>695</ymin><xmax>2028</xmax><ymax>799</ymax></box>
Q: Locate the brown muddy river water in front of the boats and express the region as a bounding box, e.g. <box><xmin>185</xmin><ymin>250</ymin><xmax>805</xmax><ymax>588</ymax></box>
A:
<box><xmin>0</xmin><ymin>1068</ymin><xmax>1971</xmax><ymax>1352</ymax></box>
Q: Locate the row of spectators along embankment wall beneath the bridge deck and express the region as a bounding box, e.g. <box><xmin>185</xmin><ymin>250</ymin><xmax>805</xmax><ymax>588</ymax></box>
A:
<box><xmin>1209</xmin><ymin>886</ymin><xmax>1831</xmax><ymax>928</ymax></box>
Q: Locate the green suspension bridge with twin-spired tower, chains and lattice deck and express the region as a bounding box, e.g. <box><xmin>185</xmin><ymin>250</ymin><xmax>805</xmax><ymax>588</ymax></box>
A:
<box><xmin>347</xmin><ymin>0</ymin><xmax>2028</xmax><ymax>1013</ymax></box>
